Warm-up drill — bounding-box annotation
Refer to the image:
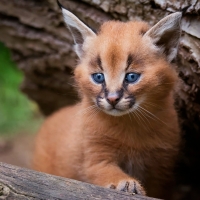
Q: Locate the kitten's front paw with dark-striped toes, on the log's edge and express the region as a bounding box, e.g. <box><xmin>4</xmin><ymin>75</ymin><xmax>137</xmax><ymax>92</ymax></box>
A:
<box><xmin>108</xmin><ymin>180</ymin><xmax>146</xmax><ymax>195</ymax></box>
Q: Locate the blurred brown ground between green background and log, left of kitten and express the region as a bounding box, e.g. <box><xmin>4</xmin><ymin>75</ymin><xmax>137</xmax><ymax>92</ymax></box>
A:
<box><xmin>0</xmin><ymin>133</ymin><xmax>35</xmax><ymax>168</ymax></box>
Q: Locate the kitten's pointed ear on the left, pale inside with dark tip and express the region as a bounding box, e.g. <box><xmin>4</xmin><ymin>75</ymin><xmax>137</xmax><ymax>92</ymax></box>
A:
<box><xmin>57</xmin><ymin>1</ymin><xmax>96</xmax><ymax>58</ymax></box>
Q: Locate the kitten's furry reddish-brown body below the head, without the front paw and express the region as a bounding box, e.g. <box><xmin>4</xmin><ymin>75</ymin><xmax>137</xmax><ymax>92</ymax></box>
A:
<box><xmin>35</xmin><ymin>98</ymin><xmax>180</xmax><ymax>197</ymax></box>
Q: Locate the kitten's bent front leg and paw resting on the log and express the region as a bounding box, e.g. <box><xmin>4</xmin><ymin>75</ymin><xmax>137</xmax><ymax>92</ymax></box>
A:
<box><xmin>85</xmin><ymin>163</ymin><xmax>146</xmax><ymax>195</ymax></box>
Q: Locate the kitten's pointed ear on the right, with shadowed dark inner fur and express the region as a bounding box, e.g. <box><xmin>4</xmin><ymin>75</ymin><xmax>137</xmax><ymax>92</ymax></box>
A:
<box><xmin>144</xmin><ymin>12</ymin><xmax>182</xmax><ymax>62</ymax></box>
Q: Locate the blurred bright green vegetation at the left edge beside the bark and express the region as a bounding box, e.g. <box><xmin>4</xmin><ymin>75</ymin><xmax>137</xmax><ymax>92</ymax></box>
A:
<box><xmin>0</xmin><ymin>43</ymin><xmax>42</xmax><ymax>135</ymax></box>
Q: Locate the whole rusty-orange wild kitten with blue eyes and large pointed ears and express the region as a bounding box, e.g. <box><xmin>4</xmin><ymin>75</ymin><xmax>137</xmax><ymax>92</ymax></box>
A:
<box><xmin>34</xmin><ymin>1</ymin><xmax>182</xmax><ymax>198</ymax></box>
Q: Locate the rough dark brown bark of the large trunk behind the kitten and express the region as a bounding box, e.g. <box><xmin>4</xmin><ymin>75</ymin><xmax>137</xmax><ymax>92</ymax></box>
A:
<box><xmin>0</xmin><ymin>0</ymin><xmax>200</xmax><ymax>199</ymax></box>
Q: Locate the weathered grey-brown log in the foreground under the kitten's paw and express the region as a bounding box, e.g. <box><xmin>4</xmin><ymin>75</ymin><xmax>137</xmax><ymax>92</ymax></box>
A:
<box><xmin>0</xmin><ymin>163</ymin><xmax>159</xmax><ymax>200</ymax></box>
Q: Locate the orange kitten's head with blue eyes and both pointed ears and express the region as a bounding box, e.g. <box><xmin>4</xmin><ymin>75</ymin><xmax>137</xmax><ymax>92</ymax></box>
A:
<box><xmin>59</xmin><ymin>3</ymin><xmax>182</xmax><ymax>116</ymax></box>
